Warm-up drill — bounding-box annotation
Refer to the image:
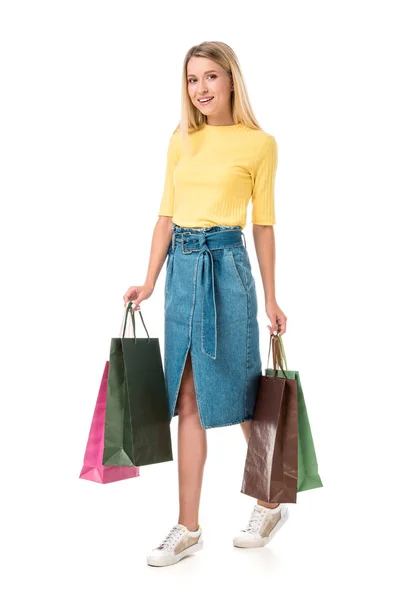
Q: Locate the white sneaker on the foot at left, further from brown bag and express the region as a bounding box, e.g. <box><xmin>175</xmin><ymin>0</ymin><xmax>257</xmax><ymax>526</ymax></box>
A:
<box><xmin>147</xmin><ymin>523</ymin><xmax>203</xmax><ymax>567</ymax></box>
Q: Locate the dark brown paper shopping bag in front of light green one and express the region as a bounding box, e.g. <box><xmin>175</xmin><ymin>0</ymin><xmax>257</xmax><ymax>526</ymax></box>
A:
<box><xmin>241</xmin><ymin>334</ymin><xmax>298</xmax><ymax>503</ymax></box>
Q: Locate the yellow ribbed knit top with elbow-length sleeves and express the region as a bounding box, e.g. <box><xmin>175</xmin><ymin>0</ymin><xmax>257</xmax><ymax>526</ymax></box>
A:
<box><xmin>158</xmin><ymin>123</ymin><xmax>278</xmax><ymax>228</ymax></box>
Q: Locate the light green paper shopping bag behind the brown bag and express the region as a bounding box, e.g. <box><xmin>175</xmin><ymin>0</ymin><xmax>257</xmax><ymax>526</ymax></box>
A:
<box><xmin>265</xmin><ymin>332</ymin><xmax>323</xmax><ymax>492</ymax></box>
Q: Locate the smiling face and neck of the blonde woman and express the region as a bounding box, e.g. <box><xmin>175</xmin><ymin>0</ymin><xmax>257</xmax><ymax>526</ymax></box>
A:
<box><xmin>187</xmin><ymin>56</ymin><xmax>233</xmax><ymax>125</ymax></box>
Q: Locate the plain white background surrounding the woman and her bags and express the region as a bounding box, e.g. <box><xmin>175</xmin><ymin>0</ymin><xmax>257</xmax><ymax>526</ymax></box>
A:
<box><xmin>0</xmin><ymin>0</ymin><xmax>400</xmax><ymax>600</ymax></box>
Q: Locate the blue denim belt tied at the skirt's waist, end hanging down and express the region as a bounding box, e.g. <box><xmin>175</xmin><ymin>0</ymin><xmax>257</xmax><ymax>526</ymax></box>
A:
<box><xmin>173</xmin><ymin>229</ymin><xmax>246</xmax><ymax>359</ymax></box>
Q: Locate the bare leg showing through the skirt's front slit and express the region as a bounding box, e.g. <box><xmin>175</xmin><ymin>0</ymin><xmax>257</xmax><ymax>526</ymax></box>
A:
<box><xmin>177</xmin><ymin>351</ymin><xmax>207</xmax><ymax>531</ymax></box>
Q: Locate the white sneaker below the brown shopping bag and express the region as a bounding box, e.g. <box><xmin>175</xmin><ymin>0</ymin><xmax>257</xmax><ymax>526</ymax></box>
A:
<box><xmin>233</xmin><ymin>504</ymin><xmax>289</xmax><ymax>548</ymax></box>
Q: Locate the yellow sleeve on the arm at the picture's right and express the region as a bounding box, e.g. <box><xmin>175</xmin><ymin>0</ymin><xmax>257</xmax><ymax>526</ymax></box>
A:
<box><xmin>251</xmin><ymin>135</ymin><xmax>278</xmax><ymax>225</ymax></box>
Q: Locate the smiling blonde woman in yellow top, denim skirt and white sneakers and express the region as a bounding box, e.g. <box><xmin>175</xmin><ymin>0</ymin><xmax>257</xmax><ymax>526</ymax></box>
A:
<box><xmin>123</xmin><ymin>42</ymin><xmax>288</xmax><ymax>566</ymax></box>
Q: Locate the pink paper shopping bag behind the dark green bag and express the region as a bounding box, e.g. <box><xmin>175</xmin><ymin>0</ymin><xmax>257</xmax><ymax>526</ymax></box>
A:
<box><xmin>79</xmin><ymin>361</ymin><xmax>140</xmax><ymax>483</ymax></box>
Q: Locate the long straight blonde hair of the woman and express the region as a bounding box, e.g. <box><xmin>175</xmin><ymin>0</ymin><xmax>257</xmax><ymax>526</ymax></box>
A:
<box><xmin>174</xmin><ymin>42</ymin><xmax>261</xmax><ymax>147</ymax></box>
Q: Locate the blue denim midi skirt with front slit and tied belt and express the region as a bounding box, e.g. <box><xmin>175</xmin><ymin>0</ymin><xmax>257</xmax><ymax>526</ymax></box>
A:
<box><xmin>164</xmin><ymin>223</ymin><xmax>261</xmax><ymax>429</ymax></box>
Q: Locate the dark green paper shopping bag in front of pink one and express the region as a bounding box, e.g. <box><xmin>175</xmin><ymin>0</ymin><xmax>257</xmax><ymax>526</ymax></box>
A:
<box><xmin>103</xmin><ymin>302</ymin><xmax>173</xmax><ymax>467</ymax></box>
